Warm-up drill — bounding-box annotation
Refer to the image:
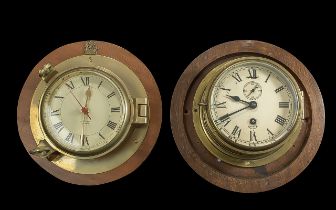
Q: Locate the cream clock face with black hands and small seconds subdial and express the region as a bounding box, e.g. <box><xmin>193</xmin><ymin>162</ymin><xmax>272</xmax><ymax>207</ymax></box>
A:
<box><xmin>209</xmin><ymin>58</ymin><xmax>298</xmax><ymax>149</ymax></box>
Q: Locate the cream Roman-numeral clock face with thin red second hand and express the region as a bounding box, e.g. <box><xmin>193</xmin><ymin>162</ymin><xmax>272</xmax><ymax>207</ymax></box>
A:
<box><xmin>41</xmin><ymin>69</ymin><xmax>129</xmax><ymax>156</ymax></box>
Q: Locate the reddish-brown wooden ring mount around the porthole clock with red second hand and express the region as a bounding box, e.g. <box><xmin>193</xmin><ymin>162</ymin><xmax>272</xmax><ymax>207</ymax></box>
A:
<box><xmin>17</xmin><ymin>41</ymin><xmax>162</xmax><ymax>185</ymax></box>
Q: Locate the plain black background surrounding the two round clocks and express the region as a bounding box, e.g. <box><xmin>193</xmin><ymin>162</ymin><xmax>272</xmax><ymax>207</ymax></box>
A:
<box><xmin>7</xmin><ymin>4</ymin><xmax>336</xmax><ymax>209</ymax></box>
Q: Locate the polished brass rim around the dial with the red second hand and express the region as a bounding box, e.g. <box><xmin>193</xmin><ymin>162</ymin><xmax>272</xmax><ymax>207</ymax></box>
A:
<box><xmin>30</xmin><ymin>55</ymin><xmax>150</xmax><ymax>174</ymax></box>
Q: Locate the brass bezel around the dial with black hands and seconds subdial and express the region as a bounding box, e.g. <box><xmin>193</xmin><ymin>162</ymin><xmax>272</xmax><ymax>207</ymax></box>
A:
<box><xmin>193</xmin><ymin>55</ymin><xmax>303</xmax><ymax>167</ymax></box>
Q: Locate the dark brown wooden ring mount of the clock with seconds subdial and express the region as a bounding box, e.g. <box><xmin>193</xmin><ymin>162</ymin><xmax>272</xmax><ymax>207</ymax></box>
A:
<box><xmin>170</xmin><ymin>40</ymin><xmax>325</xmax><ymax>193</ymax></box>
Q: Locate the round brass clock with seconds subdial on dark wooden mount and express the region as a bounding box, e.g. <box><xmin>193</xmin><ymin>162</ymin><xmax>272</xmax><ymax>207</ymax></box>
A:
<box><xmin>171</xmin><ymin>41</ymin><xmax>324</xmax><ymax>192</ymax></box>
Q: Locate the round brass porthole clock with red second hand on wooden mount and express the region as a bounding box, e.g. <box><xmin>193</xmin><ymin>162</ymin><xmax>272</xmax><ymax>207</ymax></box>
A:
<box><xmin>18</xmin><ymin>41</ymin><xmax>161</xmax><ymax>185</ymax></box>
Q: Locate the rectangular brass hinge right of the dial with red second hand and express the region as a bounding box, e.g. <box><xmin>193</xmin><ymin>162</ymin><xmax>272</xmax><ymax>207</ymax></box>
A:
<box><xmin>133</xmin><ymin>98</ymin><xmax>149</xmax><ymax>124</ymax></box>
